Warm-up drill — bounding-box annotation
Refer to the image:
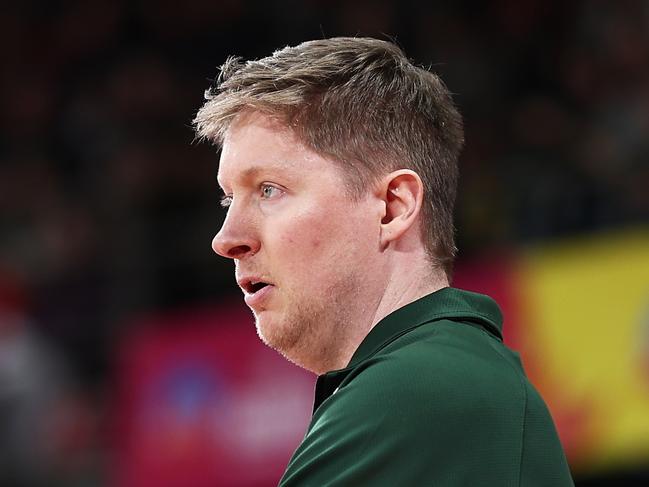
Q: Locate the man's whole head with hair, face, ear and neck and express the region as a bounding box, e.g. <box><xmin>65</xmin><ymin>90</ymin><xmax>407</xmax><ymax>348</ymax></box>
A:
<box><xmin>195</xmin><ymin>38</ymin><xmax>462</xmax><ymax>373</ymax></box>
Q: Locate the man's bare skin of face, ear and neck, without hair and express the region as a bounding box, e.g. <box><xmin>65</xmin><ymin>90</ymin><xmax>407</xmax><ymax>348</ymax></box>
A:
<box><xmin>212</xmin><ymin>112</ymin><xmax>448</xmax><ymax>374</ymax></box>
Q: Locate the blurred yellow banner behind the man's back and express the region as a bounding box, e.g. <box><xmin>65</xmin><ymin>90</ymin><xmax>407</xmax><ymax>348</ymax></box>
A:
<box><xmin>515</xmin><ymin>230</ymin><xmax>649</xmax><ymax>471</ymax></box>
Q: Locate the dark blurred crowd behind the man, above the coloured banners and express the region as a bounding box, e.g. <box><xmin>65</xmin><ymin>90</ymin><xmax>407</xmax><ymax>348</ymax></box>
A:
<box><xmin>0</xmin><ymin>0</ymin><xmax>649</xmax><ymax>485</ymax></box>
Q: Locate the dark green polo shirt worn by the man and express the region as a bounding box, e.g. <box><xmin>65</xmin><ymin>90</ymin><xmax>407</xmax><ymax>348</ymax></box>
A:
<box><xmin>280</xmin><ymin>288</ymin><xmax>574</xmax><ymax>487</ymax></box>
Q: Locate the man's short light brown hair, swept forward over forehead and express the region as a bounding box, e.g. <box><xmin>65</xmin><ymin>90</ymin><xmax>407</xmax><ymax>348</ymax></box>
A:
<box><xmin>194</xmin><ymin>37</ymin><xmax>464</xmax><ymax>278</ymax></box>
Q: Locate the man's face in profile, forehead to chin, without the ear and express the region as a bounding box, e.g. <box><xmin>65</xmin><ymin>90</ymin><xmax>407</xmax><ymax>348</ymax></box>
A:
<box><xmin>212</xmin><ymin>113</ymin><xmax>383</xmax><ymax>373</ymax></box>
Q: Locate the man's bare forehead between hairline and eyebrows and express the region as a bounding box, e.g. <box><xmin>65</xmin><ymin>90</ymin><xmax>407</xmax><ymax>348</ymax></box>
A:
<box><xmin>218</xmin><ymin>112</ymin><xmax>344</xmax><ymax>187</ymax></box>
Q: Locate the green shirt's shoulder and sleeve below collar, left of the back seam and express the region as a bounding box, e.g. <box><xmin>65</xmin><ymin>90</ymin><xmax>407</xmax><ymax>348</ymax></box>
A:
<box><xmin>282</xmin><ymin>322</ymin><xmax>569</xmax><ymax>485</ymax></box>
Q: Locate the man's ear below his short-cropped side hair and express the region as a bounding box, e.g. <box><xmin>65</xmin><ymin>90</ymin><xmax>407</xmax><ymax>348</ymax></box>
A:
<box><xmin>379</xmin><ymin>169</ymin><xmax>424</xmax><ymax>248</ymax></box>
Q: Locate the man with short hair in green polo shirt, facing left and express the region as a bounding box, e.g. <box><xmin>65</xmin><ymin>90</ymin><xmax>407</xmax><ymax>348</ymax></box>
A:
<box><xmin>195</xmin><ymin>38</ymin><xmax>572</xmax><ymax>487</ymax></box>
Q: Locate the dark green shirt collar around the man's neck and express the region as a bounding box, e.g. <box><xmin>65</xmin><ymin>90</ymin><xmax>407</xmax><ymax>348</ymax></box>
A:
<box><xmin>343</xmin><ymin>287</ymin><xmax>503</xmax><ymax>370</ymax></box>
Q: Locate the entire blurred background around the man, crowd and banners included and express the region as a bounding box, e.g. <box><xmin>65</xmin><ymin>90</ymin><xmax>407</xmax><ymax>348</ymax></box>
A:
<box><xmin>0</xmin><ymin>0</ymin><xmax>649</xmax><ymax>487</ymax></box>
